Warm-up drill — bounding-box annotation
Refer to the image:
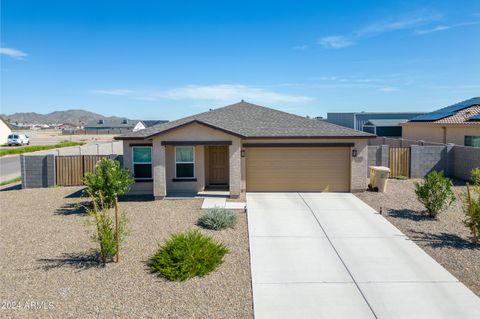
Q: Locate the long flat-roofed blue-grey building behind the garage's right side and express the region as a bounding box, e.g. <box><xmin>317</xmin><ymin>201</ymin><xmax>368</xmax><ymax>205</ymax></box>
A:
<box><xmin>327</xmin><ymin>112</ymin><xmax>424</xmax><ymax>132</ymax></box>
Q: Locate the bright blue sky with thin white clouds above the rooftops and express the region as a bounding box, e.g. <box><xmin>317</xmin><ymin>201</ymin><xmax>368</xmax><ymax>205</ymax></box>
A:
<box><xmin>0</xmin><ymin>0</ymin><xmax>480</xmax><ymax>119</ymax></box>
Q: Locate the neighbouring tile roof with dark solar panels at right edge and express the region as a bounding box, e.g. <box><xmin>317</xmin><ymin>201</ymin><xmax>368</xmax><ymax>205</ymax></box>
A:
<box><xmin>409</xmin><ymin>97</ymin><xmax>480</xmax><ymax>124</ymax></box>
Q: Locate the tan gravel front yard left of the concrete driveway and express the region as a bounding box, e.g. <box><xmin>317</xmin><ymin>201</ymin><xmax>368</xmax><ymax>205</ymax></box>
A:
<box><xmin>0</xmin><ymin>188</ymin><xmax>253</xmax><ymax>318</ymax></box>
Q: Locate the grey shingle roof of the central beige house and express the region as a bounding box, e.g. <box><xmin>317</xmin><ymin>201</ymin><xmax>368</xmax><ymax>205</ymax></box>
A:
<box><xmin>116</xmin><ymin>101</ymin><xmax>374</xmax><ymax>140</ymax></box>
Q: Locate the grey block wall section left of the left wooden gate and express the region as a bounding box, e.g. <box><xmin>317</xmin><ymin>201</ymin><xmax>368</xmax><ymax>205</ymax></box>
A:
<box><xmin>20</xmin><ymin>154</ymin><xmax>55</xmax><ymax>188</ymax></box>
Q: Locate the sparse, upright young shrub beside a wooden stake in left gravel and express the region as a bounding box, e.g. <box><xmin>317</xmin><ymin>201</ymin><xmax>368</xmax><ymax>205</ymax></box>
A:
<box><xmin>85</xmin><ymin>197</ymin><xmax>128</xmax><ymax>263</ymax></box>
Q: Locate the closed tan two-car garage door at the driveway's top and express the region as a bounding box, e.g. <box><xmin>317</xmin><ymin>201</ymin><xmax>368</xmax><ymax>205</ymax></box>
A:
<box><xmin>246</xmin><ymin>147</ymin><xmax>350</xmax><ymax>192</ymax></box>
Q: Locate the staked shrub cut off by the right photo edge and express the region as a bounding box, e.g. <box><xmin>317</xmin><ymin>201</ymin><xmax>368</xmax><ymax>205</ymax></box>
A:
<box><xmin>463</xmin><ymin>168</ymin><xmax>480</xmax><ymax>243</ymax></box>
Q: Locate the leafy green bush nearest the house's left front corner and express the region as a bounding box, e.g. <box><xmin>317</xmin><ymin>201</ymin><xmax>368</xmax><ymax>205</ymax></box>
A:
<box><xmin>83</xmin><ymin>158</ymin><xmax>133</xmax><ymax>209</ymax></box>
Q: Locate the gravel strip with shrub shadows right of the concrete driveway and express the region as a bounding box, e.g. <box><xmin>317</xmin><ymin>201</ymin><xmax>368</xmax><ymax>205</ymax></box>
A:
<box><xmin>355</xmin><ymin>179</ymin><xmax>480</xmax><ymax>296</ymax></box>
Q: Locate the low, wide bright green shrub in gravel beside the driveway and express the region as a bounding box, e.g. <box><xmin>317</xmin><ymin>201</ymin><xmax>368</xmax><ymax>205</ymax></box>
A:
<box><xmin>149</xmin><ymin>230</ymin><xmax>229</xmax><ymax>281</ymax></box>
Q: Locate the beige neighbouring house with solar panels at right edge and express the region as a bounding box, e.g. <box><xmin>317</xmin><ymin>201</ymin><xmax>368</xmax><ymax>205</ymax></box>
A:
<box><xmin>402</xmin><ymin>97</ymin><xmax>480</xmax><ymax>147</ymax></box>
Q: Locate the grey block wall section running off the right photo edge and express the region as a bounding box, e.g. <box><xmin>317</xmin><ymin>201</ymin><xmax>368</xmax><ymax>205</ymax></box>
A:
<box><xmin>452</xmin><ymin>145</ymin><xmax>480</xmax><ymax>180</ymax></box>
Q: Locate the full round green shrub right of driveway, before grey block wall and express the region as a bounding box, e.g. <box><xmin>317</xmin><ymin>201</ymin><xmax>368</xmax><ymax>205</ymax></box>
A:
<box><xmin>415</xmin><ymin>171</ymin><xmax>455</xmax><ymax>217</ymax></box>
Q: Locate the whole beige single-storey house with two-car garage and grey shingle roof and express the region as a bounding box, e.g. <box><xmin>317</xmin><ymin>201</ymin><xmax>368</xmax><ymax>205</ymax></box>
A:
<box><xmin>115</xmin><ymin>101</ymin><xmax>374</xmax><ymax>199</ymax></box>
